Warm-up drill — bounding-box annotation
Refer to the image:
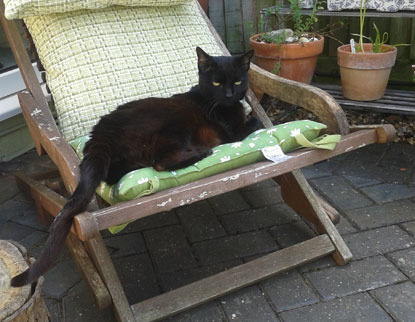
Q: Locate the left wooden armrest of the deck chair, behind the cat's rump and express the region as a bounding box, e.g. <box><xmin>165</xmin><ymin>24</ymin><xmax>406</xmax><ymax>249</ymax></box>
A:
<box><xmin>18</xmin><ymin>91</ymin><xmax>79</xmax><ymax>193</ymax></box>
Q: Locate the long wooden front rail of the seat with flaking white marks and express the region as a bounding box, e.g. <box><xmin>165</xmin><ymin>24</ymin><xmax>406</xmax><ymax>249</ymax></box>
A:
<box><xmin>75</xmin><ymin>129</ymin><xmax>384</xmax><ymax>236</ymax></box>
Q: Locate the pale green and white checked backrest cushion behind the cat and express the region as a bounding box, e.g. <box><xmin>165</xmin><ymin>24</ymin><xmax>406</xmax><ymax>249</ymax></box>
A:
<box><xmin>5</xmin><ymin>0</ymin><xmax>224</xmax><ymax>141</ymax></box>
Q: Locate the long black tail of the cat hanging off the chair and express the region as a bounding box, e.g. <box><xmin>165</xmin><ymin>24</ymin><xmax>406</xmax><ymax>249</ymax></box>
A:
<box><xmin>11</xmin><ymin>150</ymin><xmax>110</xmax><ymax>287</ymax></box>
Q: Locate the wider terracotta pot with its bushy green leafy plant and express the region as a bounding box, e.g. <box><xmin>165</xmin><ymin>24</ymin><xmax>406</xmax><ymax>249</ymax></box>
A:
<box><xmin>249</xmin><ymin>0</ymin><xmax>324</xmax><ymax>84</ymax></box>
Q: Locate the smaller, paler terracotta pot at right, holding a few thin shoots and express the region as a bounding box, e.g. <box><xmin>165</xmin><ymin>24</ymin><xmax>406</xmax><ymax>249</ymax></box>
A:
<box><xmin>337</xmin><ymin>44</ymin><xmax>397</xmax><ymax>101</ymax></box>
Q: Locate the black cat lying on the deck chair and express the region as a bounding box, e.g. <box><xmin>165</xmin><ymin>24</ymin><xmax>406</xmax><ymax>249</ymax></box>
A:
<box><xmin>11</xmin><ymin>48</ymin><xmax>259</xmax><ymax>287</ymax></box>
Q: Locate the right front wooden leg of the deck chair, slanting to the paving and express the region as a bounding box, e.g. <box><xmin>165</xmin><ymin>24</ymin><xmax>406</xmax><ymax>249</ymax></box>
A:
<box><xmin>274</xmin><ymin>170</ymin><xmax>352</xmax><ymax>265</ymax></box>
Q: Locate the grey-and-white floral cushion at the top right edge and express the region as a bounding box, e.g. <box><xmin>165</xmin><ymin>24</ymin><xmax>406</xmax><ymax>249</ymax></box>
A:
<box><xmin>327</xmin><ymin>0</ymin><xmax>415</xmax><ymax>12</ymax></box>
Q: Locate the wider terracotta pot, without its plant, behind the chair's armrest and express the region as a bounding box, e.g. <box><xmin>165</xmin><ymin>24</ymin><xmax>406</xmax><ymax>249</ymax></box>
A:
<box><xmin>249</xmin><ymin>34</ymin><xmax>324</xmax><ymax>84</ymax></box>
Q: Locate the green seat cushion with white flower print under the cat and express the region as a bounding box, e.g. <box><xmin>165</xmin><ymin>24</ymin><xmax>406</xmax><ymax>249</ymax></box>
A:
<box><xmin>71</xmin><ymin>120</ymin><xmax>340</xmax><ymax>231</ymax></box>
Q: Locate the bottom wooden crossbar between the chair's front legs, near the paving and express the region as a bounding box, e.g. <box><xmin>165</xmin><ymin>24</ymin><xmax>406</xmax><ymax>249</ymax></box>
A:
<box><xmin>132</xmin><ymin>235</ymin><xmax>334</xmax><ymax>322</ymax></box>
